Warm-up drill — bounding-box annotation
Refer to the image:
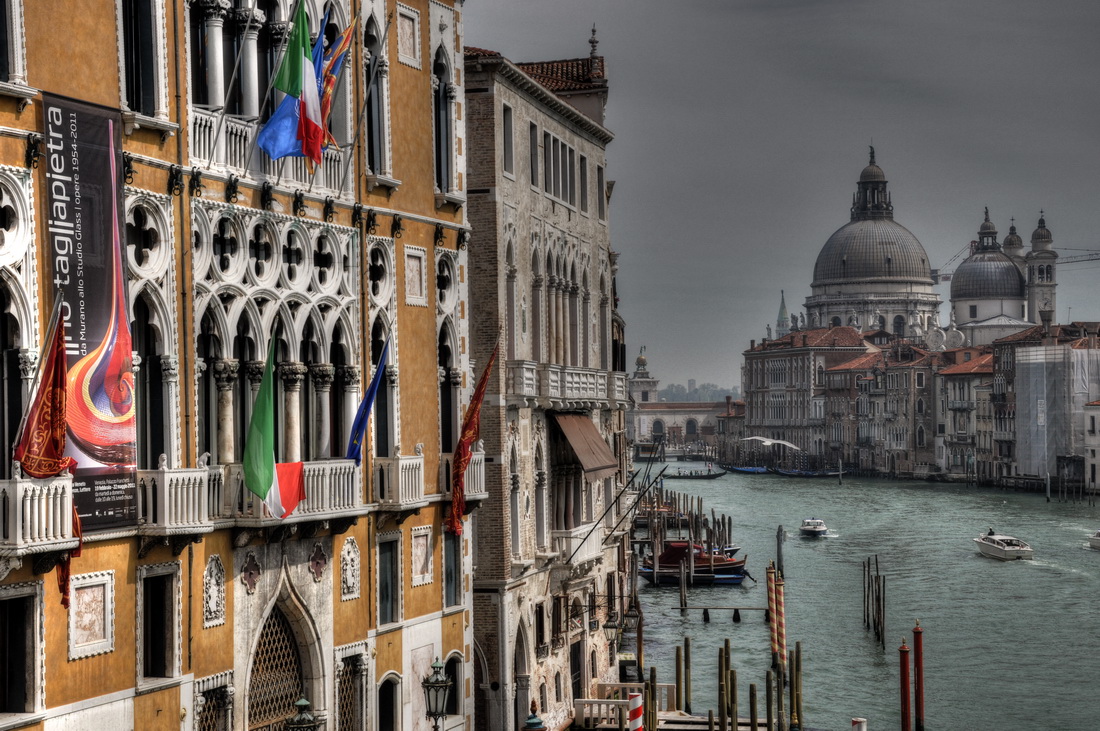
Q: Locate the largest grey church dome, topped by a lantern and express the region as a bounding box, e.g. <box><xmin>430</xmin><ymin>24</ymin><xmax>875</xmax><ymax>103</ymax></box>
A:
<box><xmin>805</xmin><ymin>147</ymin><xmax>939</xmax><ymax>336</ymax></box>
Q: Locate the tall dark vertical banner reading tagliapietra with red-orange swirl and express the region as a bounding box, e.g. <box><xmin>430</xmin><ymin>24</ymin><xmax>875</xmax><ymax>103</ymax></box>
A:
<box><xmin>43</xmin><ymin>95</ymin><xmax>138</xmax><ymax>530</ymax></box>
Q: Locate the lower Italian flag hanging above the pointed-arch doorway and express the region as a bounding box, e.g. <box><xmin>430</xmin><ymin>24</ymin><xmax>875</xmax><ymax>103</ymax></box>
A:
<box><xmin>244</xmin><ymin>337</ymin><xmax>306</xmax><ymax>518</ymax></box>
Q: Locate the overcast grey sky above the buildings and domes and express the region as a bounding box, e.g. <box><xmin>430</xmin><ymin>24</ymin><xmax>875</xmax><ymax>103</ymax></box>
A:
<box><xmin>464</xmin><ymin>0</ymin><xmax>1100</xmax><ymax>386</ymax></box>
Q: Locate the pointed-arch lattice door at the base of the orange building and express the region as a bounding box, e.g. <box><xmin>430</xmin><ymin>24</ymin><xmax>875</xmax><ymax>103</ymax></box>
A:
<box><xmin>249</xmin><ymin>607</ymin><xmax>304</xmax><ymax>731</ymax></box>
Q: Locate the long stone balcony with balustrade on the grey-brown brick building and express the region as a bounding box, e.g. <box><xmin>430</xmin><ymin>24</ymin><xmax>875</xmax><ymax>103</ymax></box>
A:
<box><xmin>505</xmin><ymin>361</ymin><xmax>627</xmax><ymax>409</ymax></box>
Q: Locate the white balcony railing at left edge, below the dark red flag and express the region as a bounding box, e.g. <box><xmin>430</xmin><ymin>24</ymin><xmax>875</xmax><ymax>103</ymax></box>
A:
<box><xmin>0</xmin><ymin>475</ymin><xmax>78</xmax><ymax>556</ymax></box>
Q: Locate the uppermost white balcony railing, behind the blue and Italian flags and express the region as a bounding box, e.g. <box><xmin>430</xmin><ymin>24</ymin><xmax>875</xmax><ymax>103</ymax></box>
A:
<box><xmin>190</xmin><ymin>109</ymin><xmax>350</xmax><ymax>196</ymax></box>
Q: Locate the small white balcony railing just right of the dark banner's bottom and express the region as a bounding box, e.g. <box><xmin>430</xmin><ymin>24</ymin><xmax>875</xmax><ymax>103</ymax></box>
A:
<box><xmin>138</xmin><ymin>467</ymin><xmax>213</xmax><ymax>535</ymax></box>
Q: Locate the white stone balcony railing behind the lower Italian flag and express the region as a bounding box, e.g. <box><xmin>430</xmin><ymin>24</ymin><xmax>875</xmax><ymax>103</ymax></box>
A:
<box><xmin>224</xmin><ymin>459</ymin><xmax>365</xmax><ymax>525</ymax></box>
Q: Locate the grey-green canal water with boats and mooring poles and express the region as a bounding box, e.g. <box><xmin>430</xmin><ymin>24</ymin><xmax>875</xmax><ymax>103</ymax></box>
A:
<box><xmin>638</xmin><ymin>465</ymin><xmax>1100</xmax><ymax>731</ymax></box>
